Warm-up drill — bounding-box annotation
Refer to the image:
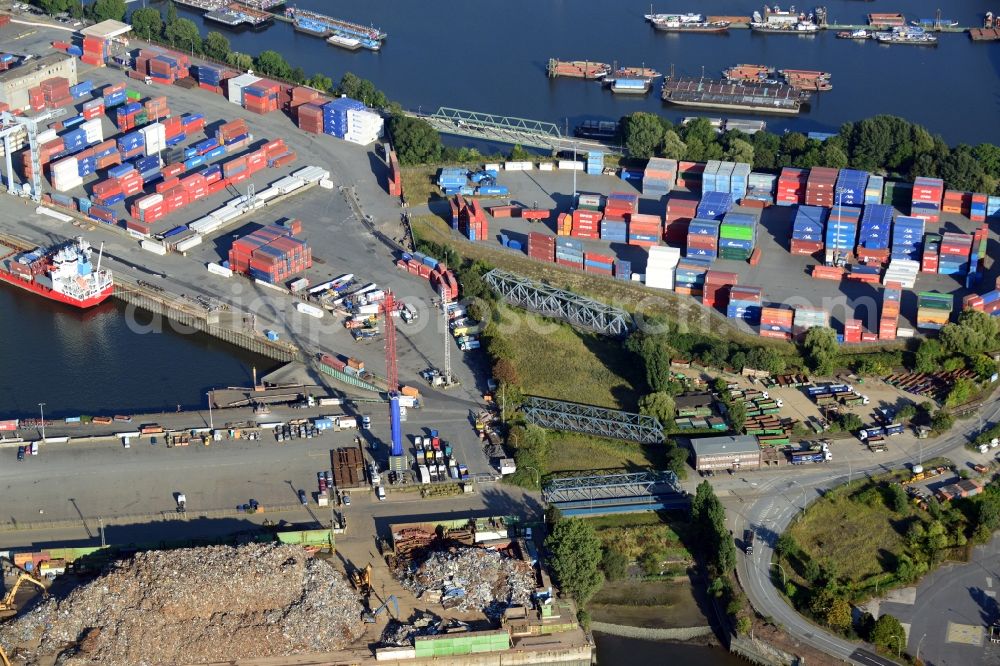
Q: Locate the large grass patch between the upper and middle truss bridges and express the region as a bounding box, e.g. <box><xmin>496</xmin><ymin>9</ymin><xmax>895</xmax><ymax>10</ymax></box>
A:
<box><xmin>503</xmin><ymin>309</ymin><xmax>644</xmax><ymax>411</ymax></box>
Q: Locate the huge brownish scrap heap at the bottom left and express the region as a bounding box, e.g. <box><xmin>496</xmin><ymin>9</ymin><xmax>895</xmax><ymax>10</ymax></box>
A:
<box><xmin>0</xmin><ymin>544</ymin><xmax>364</xmax><ymax>666</ymax></box>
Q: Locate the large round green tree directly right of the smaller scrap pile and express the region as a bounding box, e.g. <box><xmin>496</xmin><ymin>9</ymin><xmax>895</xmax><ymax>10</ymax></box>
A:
<box><xmin>545</xmin><ymin>518</ymin><xmax>602</xmax><ymax>606</ymax></box>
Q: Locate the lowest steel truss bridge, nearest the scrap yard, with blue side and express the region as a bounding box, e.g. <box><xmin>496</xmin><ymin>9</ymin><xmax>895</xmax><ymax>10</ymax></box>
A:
<box><xmin>542</xmin><ymin>470</ymin><xmax>683</xmax><ymax>505</ymax></box>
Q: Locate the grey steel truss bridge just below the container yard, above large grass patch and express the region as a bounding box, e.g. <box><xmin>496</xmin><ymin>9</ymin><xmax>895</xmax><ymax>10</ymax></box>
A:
<box><xmin>483</xmin><ymin>268</ymin><xmax>632</xmax><ymax>338</ymax></box>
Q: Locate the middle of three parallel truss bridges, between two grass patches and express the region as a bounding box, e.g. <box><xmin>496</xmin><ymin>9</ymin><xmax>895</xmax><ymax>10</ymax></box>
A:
<box><xmin>521</xmin><ymin>396</ymin><xmax>663</xmax><ymax>444</ymax></box>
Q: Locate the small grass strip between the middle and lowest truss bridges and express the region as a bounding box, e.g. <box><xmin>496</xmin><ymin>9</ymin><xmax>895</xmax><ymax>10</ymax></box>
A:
<box><xmin>545</xmin><ymin>430</ymin><xmax>666</xmax><ymax>473</ymax></box>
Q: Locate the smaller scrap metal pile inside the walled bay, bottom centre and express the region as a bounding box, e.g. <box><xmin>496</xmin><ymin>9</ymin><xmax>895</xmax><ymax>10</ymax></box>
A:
<box><xmin>397</xmin><ymin>547</ymin><xmax>535</xmax><ymax>619</ymax></box>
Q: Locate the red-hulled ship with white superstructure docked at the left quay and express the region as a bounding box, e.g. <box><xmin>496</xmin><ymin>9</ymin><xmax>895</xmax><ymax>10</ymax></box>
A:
<box><xmin>0</xmin><ymin>237</ymin><xmax>114</xmax><ymax>308</ymax></box>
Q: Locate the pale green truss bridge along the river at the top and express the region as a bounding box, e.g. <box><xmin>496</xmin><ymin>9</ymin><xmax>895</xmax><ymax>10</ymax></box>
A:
<box><xmin>405</xmin><ymin>106</ymin><xmax>622</xmax><ymax>155</ymax></box>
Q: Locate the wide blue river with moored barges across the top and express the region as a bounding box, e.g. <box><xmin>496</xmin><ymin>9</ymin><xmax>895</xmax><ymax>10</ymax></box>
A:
<box><xmin>172</xmin><ymin>0</ymin><xmax>1000</xmax><ymax>144</ymax></box>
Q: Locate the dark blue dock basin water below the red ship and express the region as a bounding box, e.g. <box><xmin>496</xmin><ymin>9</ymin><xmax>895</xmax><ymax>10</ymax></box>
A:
<box><xmin>0</xmin><ymin>283</ymin><xmax>274</xmax><ymax>418</ymax></box>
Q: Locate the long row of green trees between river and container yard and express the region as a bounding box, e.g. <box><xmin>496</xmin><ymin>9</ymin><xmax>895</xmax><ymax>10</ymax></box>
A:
<box><xmin>621</xmin><ymin>111</ymin><xmax>1000</xmax><ymax>194</ymax></box>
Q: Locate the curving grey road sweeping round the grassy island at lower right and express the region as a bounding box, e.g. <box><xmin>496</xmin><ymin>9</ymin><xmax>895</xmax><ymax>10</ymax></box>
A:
<box><xmin>726</xmin><ymin>398</ymin><xmax>1000</xmax><ymax>666</ymax></box>
